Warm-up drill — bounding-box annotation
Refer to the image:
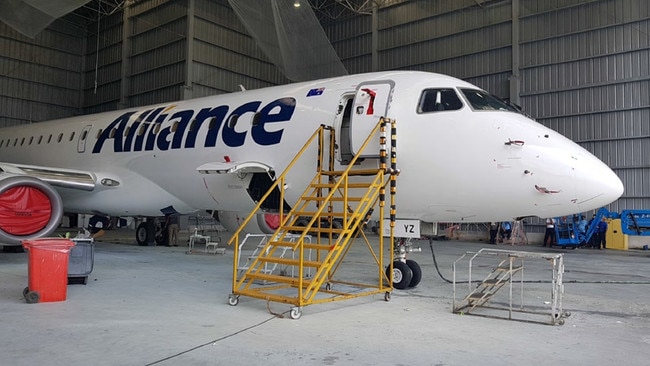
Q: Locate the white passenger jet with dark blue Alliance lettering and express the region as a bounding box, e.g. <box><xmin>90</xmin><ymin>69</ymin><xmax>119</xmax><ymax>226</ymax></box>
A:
<box><xmin>0</xmin><ymin>71</ymin><xmax>623</xmax><ymax>284</ymax></box>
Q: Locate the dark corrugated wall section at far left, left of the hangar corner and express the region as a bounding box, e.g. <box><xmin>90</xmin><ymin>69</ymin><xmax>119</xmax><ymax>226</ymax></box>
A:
<box><xmin>0</xmin><ymin>20</ymin><xmax>84</xmax><ymax>127</ymax></box>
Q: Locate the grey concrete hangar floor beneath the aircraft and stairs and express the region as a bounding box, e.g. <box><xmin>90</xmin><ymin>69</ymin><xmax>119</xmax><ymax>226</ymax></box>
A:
<box><xmin>0</xmin><ymin>232</ymin><xmax>650</xmax><ymax>366</ymax></box>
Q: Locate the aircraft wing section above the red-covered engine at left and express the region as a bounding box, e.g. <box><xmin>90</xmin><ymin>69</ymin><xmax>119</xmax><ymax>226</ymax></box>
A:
<box><xmin>0</xmin><ymin>162</ymin><xmax>97</xmax><ymax>191</ymax></box>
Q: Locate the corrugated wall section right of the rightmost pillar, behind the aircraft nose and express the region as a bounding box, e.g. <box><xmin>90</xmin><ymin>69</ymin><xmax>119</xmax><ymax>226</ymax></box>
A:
<box><xmin>521</xmin><ymin>0</ymin><xmax>650</xmax><ymax>211</ymax></box>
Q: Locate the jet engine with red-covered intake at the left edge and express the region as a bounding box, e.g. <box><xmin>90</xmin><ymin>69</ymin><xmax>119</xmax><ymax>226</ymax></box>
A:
<box><xmin>0</xmin><ymin>174</ymin><xmax>63</xmax><ymax>245</ymax></box>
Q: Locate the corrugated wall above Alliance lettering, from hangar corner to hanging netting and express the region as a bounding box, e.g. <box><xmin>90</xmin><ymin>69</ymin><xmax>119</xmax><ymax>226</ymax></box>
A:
<box><xmin>84</xmin><ymin>0</ymin><xmax>286</xmax><ymax>113</ymax></box>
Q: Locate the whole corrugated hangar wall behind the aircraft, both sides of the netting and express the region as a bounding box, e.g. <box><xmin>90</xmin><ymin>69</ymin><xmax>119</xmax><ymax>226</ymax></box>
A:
<box><xmin>0</xmin><ymin>0</ymin><xmax>650</xmax><ymax>226</ymax></box>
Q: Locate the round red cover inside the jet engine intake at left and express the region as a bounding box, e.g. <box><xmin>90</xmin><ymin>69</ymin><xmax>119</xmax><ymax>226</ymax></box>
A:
<box><xmin>0</xmin><ymin>186</ymin><xmax>52</xmax><ymax>235</ymax></box>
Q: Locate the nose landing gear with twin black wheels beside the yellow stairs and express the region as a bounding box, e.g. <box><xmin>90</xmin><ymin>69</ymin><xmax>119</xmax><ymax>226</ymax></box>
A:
<box><xmin>386</xmin><ymin>238</ymin><xmax>422</xmax><ymax>290</ymax></box>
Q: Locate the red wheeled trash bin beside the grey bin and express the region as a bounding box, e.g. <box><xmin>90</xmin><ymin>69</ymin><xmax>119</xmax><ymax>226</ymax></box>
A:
<box><xmin>23</xmin><ymin>238</ymin><xmax>74</xmax><ymax>304</ymax></box>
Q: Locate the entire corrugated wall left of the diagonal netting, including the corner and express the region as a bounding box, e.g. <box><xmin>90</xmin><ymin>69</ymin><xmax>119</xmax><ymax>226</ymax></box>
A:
<box><xmin>0</xmin><ymin>0</ymin><xmax>287</xmax><ymax>126</ymax></box>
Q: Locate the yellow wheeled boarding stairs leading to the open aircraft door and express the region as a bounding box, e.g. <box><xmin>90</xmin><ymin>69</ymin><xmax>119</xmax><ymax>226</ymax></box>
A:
<box><xmin>228</xmin><ymin>118</ymin><xmax>398</xmax><ymax>319</ymax></box>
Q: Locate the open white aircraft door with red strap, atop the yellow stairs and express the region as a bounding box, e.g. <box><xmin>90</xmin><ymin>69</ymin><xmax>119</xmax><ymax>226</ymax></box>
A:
<box><xmin>349</xmin><ymin>80</ymin><xmax>395</xmax><ymax>157</ymax></box>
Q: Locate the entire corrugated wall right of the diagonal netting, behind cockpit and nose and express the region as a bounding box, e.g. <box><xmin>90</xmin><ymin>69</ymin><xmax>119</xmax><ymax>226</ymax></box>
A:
<box><xmin>326</xmin><ymin>0</ymin><xmax>650</xmax><ymax>211</ymax></box>
